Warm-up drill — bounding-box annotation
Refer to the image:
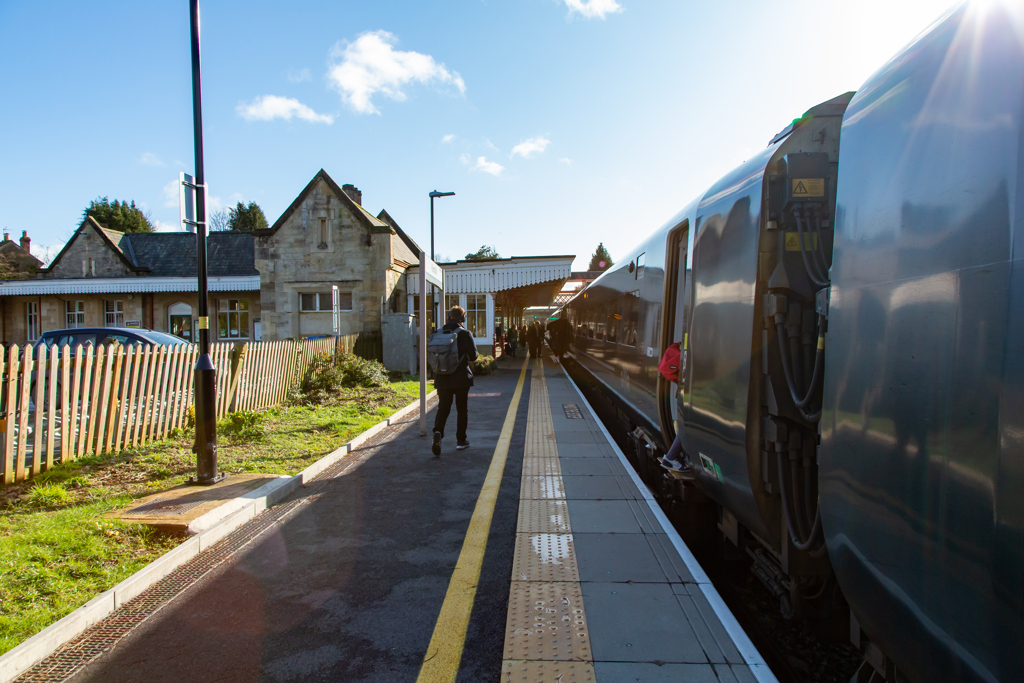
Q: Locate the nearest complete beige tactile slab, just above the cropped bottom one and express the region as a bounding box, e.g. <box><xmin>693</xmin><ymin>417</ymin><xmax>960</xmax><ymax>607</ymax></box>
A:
<box><xmin>504</xmin><ymin>582</ymin><xmax>593</xmax><ymax>661</ymax></box>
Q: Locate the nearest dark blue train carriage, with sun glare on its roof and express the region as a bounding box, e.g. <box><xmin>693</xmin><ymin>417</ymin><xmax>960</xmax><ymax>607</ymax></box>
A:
<box><xmin>819</xmin><ymin>1</ymin><xmax>1024</xmax><ymax>681</ymax></box>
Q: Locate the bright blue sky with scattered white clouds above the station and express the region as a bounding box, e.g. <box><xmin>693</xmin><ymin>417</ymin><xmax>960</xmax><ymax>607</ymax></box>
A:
<box><xmin>0</xmin><ymin>0</ymin><xmax>949</xmax><ymax>269</ymax></box>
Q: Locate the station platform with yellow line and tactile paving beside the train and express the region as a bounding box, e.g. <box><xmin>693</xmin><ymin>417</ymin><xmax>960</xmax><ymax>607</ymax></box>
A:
<box><xmin>17</xmin><ymin>354</ymin><xmax>775</xmax><ymax>683</ymax></box>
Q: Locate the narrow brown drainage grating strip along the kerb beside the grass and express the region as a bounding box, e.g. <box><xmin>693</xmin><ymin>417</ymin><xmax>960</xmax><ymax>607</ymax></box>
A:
<box><xmin>14</xmin><ymin>411</ymin><xmax>419</xmax><ymax>683</ymax></box>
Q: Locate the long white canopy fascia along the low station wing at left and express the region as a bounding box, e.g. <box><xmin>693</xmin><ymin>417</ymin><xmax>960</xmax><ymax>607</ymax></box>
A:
<box><xmin>0</xmin><ymin>275</ymin><xmax>259</xmax><ymax>296</ymax></box>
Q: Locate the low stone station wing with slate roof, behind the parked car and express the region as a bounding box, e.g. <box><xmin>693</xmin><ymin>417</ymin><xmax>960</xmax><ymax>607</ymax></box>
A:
<box><xmin>0</xmin><ymin>218</ymin><xmax>260</xmax><ymax>345</ymax></box>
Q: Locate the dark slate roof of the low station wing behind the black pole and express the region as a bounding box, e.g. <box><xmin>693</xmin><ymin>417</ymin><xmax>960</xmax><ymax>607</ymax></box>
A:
<box><xmin>124</xmin><ymin>232</ymin><xmax>259</xmax><ymax>278</ymax></box>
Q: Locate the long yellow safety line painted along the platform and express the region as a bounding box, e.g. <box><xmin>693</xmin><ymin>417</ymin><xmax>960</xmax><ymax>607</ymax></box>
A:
<box><xmin>416</xmin><ymin>358</ymin><xmax>526</xmax><ymax>683</ymax></box>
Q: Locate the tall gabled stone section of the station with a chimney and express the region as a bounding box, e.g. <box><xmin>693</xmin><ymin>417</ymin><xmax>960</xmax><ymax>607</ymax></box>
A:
<box><xmin>255</xmin><ymin>169</ymin><xmax>420</xmax><ymax>340</ymax></box>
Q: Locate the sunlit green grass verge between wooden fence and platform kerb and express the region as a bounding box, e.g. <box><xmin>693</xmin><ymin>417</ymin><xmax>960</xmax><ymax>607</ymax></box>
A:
<box><xmin>0</xmin><ymin>381</ymin><xmax>419</xmax><ymax>654</ymax></box>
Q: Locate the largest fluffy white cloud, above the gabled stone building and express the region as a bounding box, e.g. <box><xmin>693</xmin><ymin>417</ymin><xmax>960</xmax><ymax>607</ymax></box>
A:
<box><xmin>328</xmin><ymin>31</ymin><xmax>466</xmax><ymax>114</ymax></box>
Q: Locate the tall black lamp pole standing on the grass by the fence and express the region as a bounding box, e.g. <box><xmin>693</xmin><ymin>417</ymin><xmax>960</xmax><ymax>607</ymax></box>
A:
<box><xmin>188</xmin><ymin>0</ymin><xmax>224</xmax><ymax>485</ymax></box>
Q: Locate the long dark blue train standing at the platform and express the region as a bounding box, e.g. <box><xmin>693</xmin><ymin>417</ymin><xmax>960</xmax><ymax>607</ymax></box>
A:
<box><xmin>557</xmin><ymin>0</ymin><xmax>1024</xmax><ymax>683</ymax></box>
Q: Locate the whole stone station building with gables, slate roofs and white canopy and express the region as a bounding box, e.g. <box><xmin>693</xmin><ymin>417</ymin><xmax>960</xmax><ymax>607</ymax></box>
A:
<box><xmin>0</xmin><ymin>169</ymin><xmax>573</xmax><ymax>354</ymax></box>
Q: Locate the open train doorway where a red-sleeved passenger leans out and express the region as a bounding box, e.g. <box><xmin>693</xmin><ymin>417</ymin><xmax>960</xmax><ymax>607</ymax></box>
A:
<box><xmin>657</xmin><ymin>220</ymin><xmax>690</xmax><ymax>443</ymax></box>
